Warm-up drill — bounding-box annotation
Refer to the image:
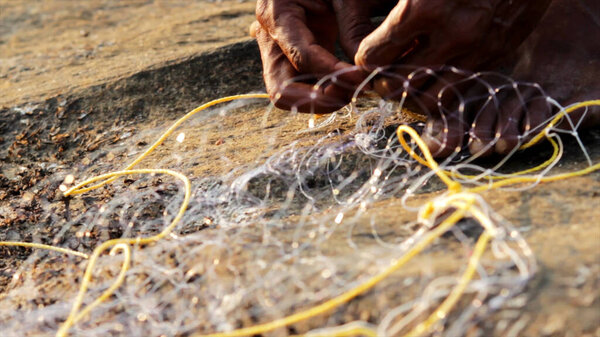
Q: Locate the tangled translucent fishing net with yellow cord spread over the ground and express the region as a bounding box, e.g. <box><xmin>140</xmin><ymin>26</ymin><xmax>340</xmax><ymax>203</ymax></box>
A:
<box><xmin>0</xmin><ymin>68</ymin><xmax>598</xmax><ymax>336</ymax></box>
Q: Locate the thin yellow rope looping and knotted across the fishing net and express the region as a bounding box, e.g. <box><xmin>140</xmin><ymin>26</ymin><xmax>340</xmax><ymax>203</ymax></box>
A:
<box><xmin>0</xmin><ymin>94</ymin><xmax>600</xmax><ymax>337</ymax></box>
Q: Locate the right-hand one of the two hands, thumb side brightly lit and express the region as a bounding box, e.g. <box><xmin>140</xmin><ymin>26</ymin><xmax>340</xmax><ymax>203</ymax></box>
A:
<box><xmin>355</xmin><ymin>0</ymin><xmax>551</xmax><ymax>114</ymax></box>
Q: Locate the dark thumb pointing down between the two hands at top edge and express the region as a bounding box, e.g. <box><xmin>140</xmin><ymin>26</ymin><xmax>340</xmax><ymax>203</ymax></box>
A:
<box><xmin>333</xmin><ymin>0</ymin><xmax>375</xmax><ymax>59</ymax></box>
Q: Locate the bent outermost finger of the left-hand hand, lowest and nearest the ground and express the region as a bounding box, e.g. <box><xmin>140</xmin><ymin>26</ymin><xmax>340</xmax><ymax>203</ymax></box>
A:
<box><xmin>255</xmin><ymin>27</ymin><xmax>348</xmax><ymax>113</ymax></box>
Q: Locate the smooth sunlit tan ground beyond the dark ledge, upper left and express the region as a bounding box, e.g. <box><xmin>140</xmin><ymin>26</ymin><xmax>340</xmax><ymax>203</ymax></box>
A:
<box><xmin>0</xmin><ymin>0</ymin><xmax>254</xmax><ymax>106</ymax></box>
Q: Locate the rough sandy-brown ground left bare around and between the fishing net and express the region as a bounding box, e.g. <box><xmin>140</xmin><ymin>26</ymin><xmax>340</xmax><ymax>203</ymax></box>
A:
<box><xmin>0</xmin><ymin>0</ymin><xmax>600</xmax><ymax>336</ymax></box>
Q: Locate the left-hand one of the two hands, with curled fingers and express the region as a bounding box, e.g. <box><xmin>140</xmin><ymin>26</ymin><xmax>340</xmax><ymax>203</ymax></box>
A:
<box><xmin>251</xmin><ymin>0</ymin><xmax>395</xmax><ymax>113</ymax></box>
